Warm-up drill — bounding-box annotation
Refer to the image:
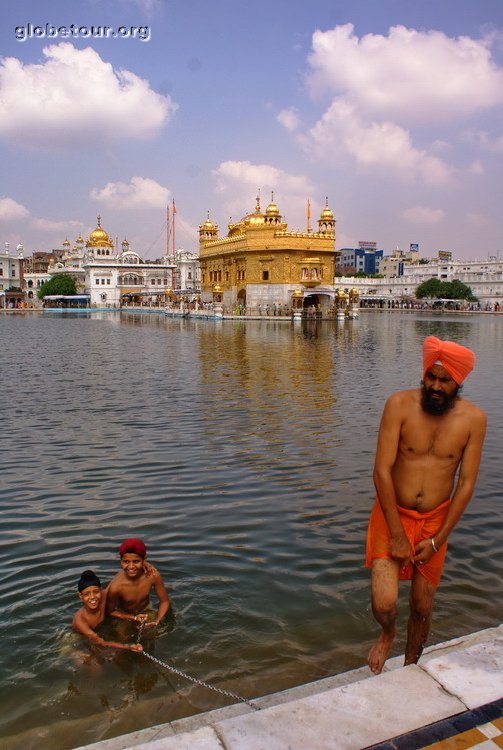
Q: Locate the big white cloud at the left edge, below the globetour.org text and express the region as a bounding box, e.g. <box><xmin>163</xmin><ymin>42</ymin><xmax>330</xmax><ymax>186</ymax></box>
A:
<box><xmin>0</xmin><ymin>42</ymin><xmax>177</xmax><ymax>150</ymax></box>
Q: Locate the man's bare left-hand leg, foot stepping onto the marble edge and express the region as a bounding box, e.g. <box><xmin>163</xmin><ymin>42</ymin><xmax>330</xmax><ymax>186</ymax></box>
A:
<box><xmin>367</xmin><ymin>560</ymin><xmax>398</xmax><ymax>674</ymax></box>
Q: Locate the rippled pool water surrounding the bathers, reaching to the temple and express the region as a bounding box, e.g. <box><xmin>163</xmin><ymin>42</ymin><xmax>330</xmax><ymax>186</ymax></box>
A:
<box><xmin>0</xmin><ymin>312</ymin><xmax>503</xmax><ymax>750</ymax></box>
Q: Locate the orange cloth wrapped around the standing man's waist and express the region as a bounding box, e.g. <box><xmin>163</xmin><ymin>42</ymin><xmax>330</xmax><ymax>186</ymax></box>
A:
<box><xmin>365</xmin><ymin>498</ymin><xmax>451</xmax><ymax>586</ymax></box>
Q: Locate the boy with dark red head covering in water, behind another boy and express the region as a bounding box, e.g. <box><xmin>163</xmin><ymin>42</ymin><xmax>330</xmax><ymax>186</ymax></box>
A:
<box><xmin>106</xmin><ymin>539</ymin><xmax>170</xmax><ymax>628</ymax></box>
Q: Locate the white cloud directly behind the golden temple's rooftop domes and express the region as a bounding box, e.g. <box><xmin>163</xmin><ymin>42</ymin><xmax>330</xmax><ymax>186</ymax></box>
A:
<box><xmin>213</xmin><ymin>161</ymin><xmax>317</xmax><ymax>221</ymax></box>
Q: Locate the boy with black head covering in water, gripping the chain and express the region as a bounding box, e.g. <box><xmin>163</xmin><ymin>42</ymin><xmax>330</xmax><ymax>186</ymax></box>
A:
<box><xmin>72</xmin><ymin>570</ymin><xmax>143</xmax><ymax>651</ymax></box>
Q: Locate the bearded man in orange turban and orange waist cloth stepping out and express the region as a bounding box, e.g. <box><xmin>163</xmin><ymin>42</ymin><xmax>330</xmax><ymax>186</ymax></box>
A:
<box><xmin>365</xmin><ymin>336</ymin><xmax>486</xmax><ymax>674</ymax></box>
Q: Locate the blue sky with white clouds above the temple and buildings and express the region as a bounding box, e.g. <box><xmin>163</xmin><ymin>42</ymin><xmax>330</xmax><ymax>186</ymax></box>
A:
<box><xmin>0</xmin><ymin>0</ymin><xmax>503</xmax><ymax>259</ymax></box>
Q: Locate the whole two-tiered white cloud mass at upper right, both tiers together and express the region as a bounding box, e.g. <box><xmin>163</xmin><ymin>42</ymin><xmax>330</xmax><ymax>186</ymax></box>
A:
<box><xmin>299</xmin><ymin>24</ymin><xmax>503</xmax><ymax>186</ymax></box>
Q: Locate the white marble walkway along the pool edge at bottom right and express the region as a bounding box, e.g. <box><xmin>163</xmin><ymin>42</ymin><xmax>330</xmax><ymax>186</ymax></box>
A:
<box><xmin>80</xmin><ymin>625</ymin><xmax>503</xmax><ymax>750</ymax></box>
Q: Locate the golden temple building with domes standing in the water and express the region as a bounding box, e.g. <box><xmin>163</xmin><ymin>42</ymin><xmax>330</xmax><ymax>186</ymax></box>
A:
<box><xmin>199</xmin><ymin>195</ymin><xmax>337</xmax><ymax>314</ymax></box>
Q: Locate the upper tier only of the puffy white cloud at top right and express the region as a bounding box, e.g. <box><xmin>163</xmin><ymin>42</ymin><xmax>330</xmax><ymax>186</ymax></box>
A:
<box><xmin>309</xmin><ymin>24</ymin><xmax>503</xmax><ymax>123</ymax></box>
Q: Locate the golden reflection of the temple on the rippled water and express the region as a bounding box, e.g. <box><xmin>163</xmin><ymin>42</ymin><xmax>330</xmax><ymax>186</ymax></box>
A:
<box><xmin>197</xmin><ymin>321</ymin><xmax>342</xmax><ymax>486</ymax></box>
